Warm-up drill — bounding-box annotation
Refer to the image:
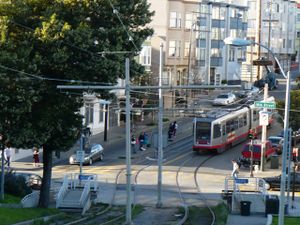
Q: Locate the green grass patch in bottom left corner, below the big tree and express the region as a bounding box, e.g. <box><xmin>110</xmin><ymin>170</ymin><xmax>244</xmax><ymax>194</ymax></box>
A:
<box><xmin>0</xmin><ymin>208</ymin><xmax>59</xmax><ymax>225</ymax></box>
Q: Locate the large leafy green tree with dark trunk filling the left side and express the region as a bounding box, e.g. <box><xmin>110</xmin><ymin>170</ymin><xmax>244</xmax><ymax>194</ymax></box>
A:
<box><xmin>0</xmin><ymin>0</ymin><xmax>153</xmax><ymax>207</ymax></box>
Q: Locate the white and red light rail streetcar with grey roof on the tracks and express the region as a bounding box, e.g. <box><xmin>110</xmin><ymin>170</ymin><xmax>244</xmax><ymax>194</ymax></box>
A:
<box><xmin>193</xmin><ymin>97</ymin><xmax>275</xmax><ymax>153</ymax></box>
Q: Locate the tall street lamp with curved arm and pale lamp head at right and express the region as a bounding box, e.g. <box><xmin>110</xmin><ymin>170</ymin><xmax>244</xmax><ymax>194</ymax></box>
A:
<box><xmin>224</xmin><ymin>37</ymin><xmax>290</xmax><ymax>225</ymax></box>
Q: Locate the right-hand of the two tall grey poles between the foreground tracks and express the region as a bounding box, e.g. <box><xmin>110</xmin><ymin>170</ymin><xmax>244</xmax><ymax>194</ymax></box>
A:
<box><xmin>156</xmin><ymin>43</ymin><xmax>163</xmax><ymax>208</ymax></box>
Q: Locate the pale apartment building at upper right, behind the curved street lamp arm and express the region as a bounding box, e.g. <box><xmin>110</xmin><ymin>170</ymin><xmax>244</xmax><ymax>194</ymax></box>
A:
<box><xmin>242</xmin><ymin>0</ymin><xmax>297</xmax><ymax>81</ymax></box>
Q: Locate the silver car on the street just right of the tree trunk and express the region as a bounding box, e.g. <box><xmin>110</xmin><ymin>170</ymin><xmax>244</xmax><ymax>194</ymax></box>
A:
<box><xmin>69</xmin><ymin>144</ymin><xmax>104</xmax><ymax>165</ymax></box>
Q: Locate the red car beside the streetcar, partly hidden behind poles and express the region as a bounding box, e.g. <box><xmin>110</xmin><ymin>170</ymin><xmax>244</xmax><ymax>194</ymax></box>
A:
<box><xmin>242</xmin><ymin>140</ymin><xmax>276</xmax><ymax>162</ymax></box>
